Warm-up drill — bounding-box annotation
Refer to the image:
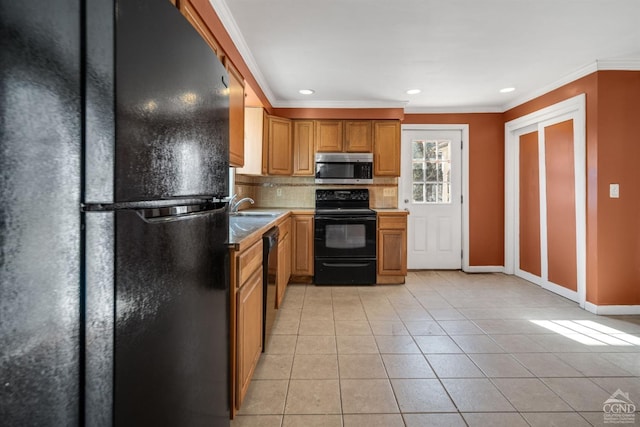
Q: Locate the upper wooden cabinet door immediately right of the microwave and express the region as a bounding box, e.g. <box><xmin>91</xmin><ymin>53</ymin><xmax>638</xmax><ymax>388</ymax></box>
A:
<box><xmin>373</xmin><ymin>120</ymin><xmax>400</xmax><ymax>176</ymax></box>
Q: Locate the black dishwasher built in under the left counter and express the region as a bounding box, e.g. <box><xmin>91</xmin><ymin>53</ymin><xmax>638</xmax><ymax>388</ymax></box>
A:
<box><xmin>262</xmin><ymin>227</ymin><xmax>280</xmax><ymax>352</ymax></box>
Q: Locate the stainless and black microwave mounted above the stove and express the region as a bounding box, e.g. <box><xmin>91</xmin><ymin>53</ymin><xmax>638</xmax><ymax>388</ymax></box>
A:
<box><xmin>316</xmin><ymin>153</ymin><xmax>373</xmax><ymax>184</ymax></box>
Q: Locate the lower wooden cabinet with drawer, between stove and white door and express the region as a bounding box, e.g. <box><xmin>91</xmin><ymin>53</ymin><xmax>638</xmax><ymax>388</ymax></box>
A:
<box><xmin>377</xmin><ymin>211</ymin><xmax>407</xmax><ymax>284</ymax></box>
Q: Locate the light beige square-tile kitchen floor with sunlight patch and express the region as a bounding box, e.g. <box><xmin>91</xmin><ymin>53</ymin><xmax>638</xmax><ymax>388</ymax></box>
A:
<box><xmin>231</xmin><ymin>271</ymin><xmax>640</xmax><ymax>427</ymax></box>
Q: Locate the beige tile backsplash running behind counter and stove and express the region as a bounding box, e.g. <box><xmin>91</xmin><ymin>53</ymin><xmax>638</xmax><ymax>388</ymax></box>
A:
<box><xmin>235</xmin><ymin>174</ymin><xmax>398</xmax><ymax>209</ymax></box>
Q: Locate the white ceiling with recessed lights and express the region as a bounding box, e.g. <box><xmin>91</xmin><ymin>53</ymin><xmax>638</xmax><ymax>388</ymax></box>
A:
<box><xmin>210</xmin><ymin>0</ymin><xmax>640</xmax><ymax>112</ymax></box>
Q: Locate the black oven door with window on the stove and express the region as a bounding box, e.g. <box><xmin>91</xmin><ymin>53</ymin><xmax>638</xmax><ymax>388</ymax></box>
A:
<box><xmin>314</xmin><ymin>215</ymin><xmax>376</xmax><ymax>258</ymax></box>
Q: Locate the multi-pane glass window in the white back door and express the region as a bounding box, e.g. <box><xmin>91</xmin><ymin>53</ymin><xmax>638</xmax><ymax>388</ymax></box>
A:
<box><xmin>412</xmin><ymin>140</ymin><xmax>451</xmax><ymax>203</ymax></box>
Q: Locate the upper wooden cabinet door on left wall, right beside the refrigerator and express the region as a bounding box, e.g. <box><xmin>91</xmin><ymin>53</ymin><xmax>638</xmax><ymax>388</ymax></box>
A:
<box><xmin>225</xmin><ymin>58</ymin><xmax>244</xmax><ymax>167</ymax></box>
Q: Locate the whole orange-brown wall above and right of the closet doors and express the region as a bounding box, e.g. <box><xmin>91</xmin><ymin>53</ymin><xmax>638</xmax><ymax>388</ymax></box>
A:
<box><xmin>504</xmin><ymin>71</ymin><xmax>640</xmax><ymax>305</ymax></box>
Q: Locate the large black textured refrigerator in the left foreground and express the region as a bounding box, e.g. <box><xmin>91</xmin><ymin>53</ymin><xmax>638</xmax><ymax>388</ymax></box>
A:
<box><xmin>0</xmin><ymin>0</ymin><xmax>229</xmax><ymax>426</ymax></box>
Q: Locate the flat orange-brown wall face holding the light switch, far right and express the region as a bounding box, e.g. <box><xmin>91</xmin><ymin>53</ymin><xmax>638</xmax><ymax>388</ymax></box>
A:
<box><xmin>587</xmin><ymin>71</ymin><xmax>640</xmax><ymax>305</ymax></box>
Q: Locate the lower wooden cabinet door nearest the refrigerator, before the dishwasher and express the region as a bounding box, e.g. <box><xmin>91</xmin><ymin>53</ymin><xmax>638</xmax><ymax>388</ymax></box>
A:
<box><xmin>236</xmin><ymin>267</ymin><xmax>262</xmax><ymax>409</ymax></box>
